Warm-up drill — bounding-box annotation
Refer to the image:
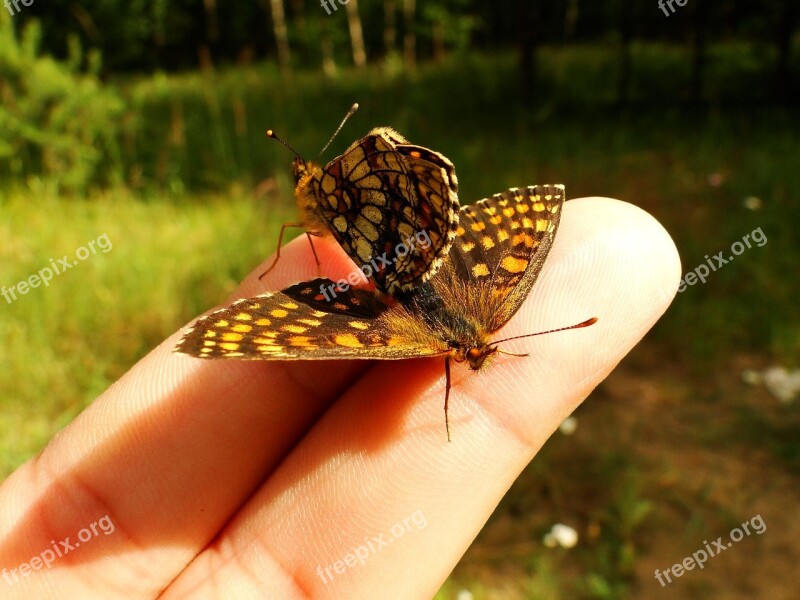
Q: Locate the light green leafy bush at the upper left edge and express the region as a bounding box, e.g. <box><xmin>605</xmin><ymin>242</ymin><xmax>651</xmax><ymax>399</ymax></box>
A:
<box><xmin>0</xmin><ymin>11</ymin><xmax>123</xmax><ymax>191</ymax></box>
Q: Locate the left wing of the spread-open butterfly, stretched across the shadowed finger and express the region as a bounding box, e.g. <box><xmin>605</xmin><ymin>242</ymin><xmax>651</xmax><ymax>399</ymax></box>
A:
<box><xmin>175</xmin><ymin>278</ymin><xmax>442</xmax><ymax>360</ymax></box>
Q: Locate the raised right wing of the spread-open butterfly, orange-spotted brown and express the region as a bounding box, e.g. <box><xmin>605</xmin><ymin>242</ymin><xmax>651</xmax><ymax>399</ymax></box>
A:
<box><xmin>430</xmin><ymin>185</ymin><xmax>564</xmax><ymax>332</ymax></box>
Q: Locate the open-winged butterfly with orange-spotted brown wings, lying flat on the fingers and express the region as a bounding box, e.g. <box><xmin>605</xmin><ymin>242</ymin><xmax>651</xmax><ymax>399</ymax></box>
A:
<box><xmin>175</xmin><ymin>185</ymin><xmax>596</xmax><ymax>440</ymax></box>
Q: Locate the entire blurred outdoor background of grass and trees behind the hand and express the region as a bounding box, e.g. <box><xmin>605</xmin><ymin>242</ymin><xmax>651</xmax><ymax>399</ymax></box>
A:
<box><xmin>0</xmin><ymin>0</ymin><xmax>800</xmax><ymax>600</ymax></box>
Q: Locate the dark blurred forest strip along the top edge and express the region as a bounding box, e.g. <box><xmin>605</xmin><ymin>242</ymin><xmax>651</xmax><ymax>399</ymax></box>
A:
<box><xmin>14</xmin><ymin>0</ymin><xmax>799</xmax><ymax>74</ymax></box>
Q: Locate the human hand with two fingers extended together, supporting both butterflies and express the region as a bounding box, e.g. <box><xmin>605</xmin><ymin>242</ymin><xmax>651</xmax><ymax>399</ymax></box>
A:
<box><xmin>0</xmin><ymin>198</ymin><xmax>680</xmax><ymax>598</ymax></box>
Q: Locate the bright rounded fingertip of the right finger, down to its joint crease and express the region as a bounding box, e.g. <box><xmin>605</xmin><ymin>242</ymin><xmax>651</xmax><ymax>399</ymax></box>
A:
<box><xmin>472</xmin><ymin>198</ymin><xmax>681</xmax><ymax>447</ymax></box>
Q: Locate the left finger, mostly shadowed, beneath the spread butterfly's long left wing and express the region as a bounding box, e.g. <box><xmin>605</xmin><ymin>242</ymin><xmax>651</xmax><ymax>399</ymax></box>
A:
<box><xmin>0</xmin><ymin>236</ymin><xmax>366</xmax><ymax>598</ymax></box>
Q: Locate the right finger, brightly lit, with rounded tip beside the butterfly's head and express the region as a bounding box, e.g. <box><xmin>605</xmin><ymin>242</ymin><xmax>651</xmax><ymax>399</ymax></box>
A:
<box><xmin>166</xmin><ymin>199</ymin><xmax>680</xmax><ymax>598</ymax></box>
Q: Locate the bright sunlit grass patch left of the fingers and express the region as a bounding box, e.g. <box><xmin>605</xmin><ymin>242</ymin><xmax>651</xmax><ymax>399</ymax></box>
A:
<box><xmin>0</xmin><ymin>185</ymin><xmax>290</xmax><ymax>473</ymax></box>
